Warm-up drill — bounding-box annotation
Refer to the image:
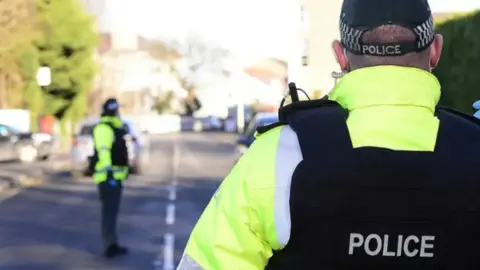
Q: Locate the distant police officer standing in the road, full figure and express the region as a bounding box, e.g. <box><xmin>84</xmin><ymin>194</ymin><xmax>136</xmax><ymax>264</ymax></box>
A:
<box><xmin>91</xmin><ymin>98</ymin><xmax>128</xmax><ymax>258</ymax></box>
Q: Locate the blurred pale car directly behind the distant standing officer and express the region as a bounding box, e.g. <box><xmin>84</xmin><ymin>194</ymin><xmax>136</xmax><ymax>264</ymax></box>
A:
<box><xmin>71</xmin><ymin>119</ymin><xmax>150</xmax><ymax>176</ymax></box>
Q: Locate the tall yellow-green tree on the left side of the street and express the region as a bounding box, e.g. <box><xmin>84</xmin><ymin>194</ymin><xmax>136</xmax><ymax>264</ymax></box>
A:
<box><xmin>35</xmin><ymin>0</ymin><xmax>98</xmax><ymax>126</ymax></box>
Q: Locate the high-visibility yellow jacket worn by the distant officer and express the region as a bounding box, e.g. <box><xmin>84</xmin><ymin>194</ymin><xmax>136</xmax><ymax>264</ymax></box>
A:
<box><xmin>93</xmin><ymin>116</ymin><xmax>128</xmax><ymax>184</ymax></box>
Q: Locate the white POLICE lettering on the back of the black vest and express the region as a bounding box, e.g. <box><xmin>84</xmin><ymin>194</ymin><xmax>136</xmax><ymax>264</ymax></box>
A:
<box><xmin>348</xmin><ymin>233</ymin><xmax>435</xmax><ymax>258</ymax></box>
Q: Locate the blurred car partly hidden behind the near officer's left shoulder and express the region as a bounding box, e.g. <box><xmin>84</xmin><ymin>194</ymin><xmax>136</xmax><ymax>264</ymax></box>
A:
<box><xmin>236</xmin><ymin>112</ymin><xmax>278</xmax><ymax>160</ymax></box>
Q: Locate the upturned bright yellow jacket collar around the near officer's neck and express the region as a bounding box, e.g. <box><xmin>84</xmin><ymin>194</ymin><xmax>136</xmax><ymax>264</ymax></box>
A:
<box><xmin>329</xmin><ymin>66</ymin><xmax>440</xmax><ymax>112</ymax></box>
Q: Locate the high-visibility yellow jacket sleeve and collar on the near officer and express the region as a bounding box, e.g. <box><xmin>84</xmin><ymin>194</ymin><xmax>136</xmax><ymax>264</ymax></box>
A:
<box><xmin>178</xmin><ymin>66</ymin><xmax>440</xmax><ymax>270</ymax></box>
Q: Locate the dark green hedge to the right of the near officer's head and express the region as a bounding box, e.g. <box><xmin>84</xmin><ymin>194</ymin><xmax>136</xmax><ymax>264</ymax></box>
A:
<box><xmin>434</xmin><ymin>11</ymin><xmax>480</xmax><ymax>114</ymax></box>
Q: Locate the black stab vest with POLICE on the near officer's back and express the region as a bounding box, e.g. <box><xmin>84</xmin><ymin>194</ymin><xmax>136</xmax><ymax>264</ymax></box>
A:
<box><xmin>259</xmin><ymin>100</ymin><xmax>480</xmax><ymax>270</ymax></box>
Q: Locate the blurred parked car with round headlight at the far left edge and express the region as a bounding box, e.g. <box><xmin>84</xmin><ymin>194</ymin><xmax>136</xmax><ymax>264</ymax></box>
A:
<box><xmin>0</xmin><ymin>124</ymin><xmax>53</xmax><ymax>163</ymax></box>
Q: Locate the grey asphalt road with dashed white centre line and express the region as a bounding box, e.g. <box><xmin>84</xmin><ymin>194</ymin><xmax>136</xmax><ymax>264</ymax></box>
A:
<box><xmin>0</xmin><ymin>133</ymin><xmax>235</xmax><ymax>270</ymax></box>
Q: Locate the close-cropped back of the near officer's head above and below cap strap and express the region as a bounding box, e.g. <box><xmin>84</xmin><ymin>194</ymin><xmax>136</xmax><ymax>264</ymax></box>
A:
<box><xmin>348</xmin><ymin>25</ymin><xmax>430</xmax><ymax>70</ymax></box>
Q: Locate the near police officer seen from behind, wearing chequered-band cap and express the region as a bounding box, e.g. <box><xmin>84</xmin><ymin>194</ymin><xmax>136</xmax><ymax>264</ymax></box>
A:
<box><xmin>178</xmin><ymin>0</ymin><xmax>480</xmax><ymax>270</ymax></box>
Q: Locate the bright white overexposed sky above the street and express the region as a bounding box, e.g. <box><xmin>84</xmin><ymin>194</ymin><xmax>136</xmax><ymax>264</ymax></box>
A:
<box><xmin>98</xmin><ymin>0</ymin><xmax>480</xmax><ymax>66</ymax></box>
